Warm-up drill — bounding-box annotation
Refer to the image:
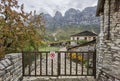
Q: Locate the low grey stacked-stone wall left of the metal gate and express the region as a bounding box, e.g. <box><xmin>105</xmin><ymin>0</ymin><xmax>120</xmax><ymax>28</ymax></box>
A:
<box><xmin>0</xmin><ymin>53</ymin><xmax>22</xmax><ymax>81</ymax></box>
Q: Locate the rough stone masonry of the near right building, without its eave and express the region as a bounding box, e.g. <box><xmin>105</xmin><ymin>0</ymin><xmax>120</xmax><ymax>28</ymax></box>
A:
<box><xmin>97</xmin><ymin>0</ymin><xmax>120</xmax><ymax>81</ymax></box>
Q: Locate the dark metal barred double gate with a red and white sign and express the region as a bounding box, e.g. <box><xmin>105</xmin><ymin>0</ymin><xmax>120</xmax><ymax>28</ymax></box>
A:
<box><xmin>22</xmin><ymin>51</ymin><xmax>96</xmax><ymax>78</ymax></box>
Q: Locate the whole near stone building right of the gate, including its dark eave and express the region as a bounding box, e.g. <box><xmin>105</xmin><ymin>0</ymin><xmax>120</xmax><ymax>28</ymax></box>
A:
<box><xmin>96</xmin><ymin>0</ymin><xmax>120</xmax><ymax>81</ymax></box>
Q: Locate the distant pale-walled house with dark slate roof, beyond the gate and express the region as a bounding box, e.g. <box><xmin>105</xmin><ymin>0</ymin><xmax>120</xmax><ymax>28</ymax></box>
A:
<box><xmin>70</xmin><ymin>31</ymin><xmax>97</xmax><ymax>46</ymax></box>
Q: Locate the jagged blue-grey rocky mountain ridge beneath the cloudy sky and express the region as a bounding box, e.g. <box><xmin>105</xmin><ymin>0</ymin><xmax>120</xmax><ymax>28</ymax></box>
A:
<box><xmin>43</xmin><ymin>6</ymin><xmax>99</xmax><ymax>27</ymax></box>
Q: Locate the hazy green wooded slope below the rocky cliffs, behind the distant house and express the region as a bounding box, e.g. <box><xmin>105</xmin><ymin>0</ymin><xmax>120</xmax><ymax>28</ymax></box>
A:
<box><xmin>45</xmin><ymin>25</ymin><xmax>100</xmax><ymax>42</ymax></box>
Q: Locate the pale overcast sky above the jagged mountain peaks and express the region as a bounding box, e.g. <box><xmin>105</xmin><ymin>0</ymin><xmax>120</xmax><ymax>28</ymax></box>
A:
<box><xmin>19</xmin><ymin>0</ymin><xmax>98</xmax><ymax>16</ymax></box>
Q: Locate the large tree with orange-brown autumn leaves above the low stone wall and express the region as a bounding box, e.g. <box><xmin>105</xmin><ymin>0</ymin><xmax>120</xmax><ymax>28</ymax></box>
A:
<box><xmin>0</xmin><ymin>0</ymin><xmax>45</xmax><ymax>57</ymax></box>
